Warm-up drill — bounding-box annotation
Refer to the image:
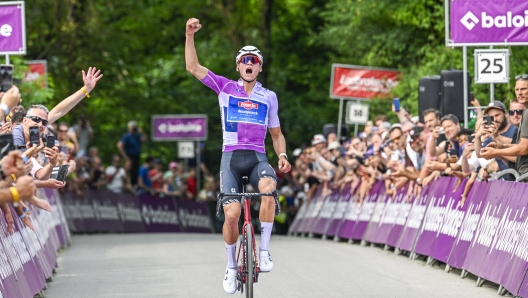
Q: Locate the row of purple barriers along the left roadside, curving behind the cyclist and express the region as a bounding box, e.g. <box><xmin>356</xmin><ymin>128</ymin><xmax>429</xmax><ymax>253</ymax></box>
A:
<box><xmin>0</xmin><ymin>189</ymin><xmax>213</xmax><ymax>298</ymax></box>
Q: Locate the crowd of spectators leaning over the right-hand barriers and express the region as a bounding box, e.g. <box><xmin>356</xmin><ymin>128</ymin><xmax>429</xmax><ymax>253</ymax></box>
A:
<box><xmin>284</xmin><ymin>75</ymin><xmax>528</xmax><ymax>217</ymax></box>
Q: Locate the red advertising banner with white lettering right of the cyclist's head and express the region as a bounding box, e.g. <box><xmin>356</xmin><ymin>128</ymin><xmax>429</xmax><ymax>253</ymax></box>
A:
<box><xmin>330</xmin><ymin>64</ymin><xmax>400</xmax><ymax>99</ymax></box>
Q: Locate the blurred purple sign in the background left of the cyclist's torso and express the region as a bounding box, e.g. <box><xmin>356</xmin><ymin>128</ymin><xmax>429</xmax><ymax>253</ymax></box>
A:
<box><xmin>152</xmin><ymin>115</ymin><xmax>207</xmax><ymax>141</ymax></box>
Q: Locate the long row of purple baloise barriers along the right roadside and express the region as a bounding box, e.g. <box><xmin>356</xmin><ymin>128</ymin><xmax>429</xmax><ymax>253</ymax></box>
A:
<box><xmin>289</xmin><ymin>177</ymin><xmax>528</xmax><ymax>297</ymax></box>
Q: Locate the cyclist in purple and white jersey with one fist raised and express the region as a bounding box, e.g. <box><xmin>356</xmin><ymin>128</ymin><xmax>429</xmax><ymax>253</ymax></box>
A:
<box><xmin>185</xmin><ymin>18</ymin><xmax>291</xmax><ymax>294</ymax></box>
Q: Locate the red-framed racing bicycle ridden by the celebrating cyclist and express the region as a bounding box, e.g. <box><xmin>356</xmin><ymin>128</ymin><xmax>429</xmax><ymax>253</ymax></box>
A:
<box><xmin>217</xmin><ymin>176</ymin><xmax>280</xmax><ymax>298</ymax></box>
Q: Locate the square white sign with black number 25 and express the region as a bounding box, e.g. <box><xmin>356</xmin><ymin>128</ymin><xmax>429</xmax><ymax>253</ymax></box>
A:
<box><xmin>475</xmin><ymin>49</ymin><xmax>510</xmax><ymax>84</ymax></box>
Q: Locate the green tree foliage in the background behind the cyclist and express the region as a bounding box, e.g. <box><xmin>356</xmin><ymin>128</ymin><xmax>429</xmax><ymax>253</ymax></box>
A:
<box><xmin>16</xmin><ymin>0</ymin><xmax>528</xmax><ymax>170</ymax></box>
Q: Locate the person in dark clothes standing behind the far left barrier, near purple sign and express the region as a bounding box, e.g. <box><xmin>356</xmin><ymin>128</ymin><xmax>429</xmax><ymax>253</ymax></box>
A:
<box><xmin>117</xmin><ymin>121</ymin><xmax>145</xmax><ymax>186</ymax></box>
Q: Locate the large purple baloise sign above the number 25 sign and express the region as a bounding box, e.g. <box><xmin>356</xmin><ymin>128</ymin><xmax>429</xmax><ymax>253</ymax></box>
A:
<box><xmin>450</xmin><ymin>0</ymin><xmax>528</xmax><ymax>44</ymax></box>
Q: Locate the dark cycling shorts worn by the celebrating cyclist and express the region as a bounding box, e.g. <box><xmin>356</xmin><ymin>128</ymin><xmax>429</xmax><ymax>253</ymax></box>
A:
<box><xmin>220</xmin><ymin>150</ymin><xmax>277</xmax><ymax>206</ymax></box>
